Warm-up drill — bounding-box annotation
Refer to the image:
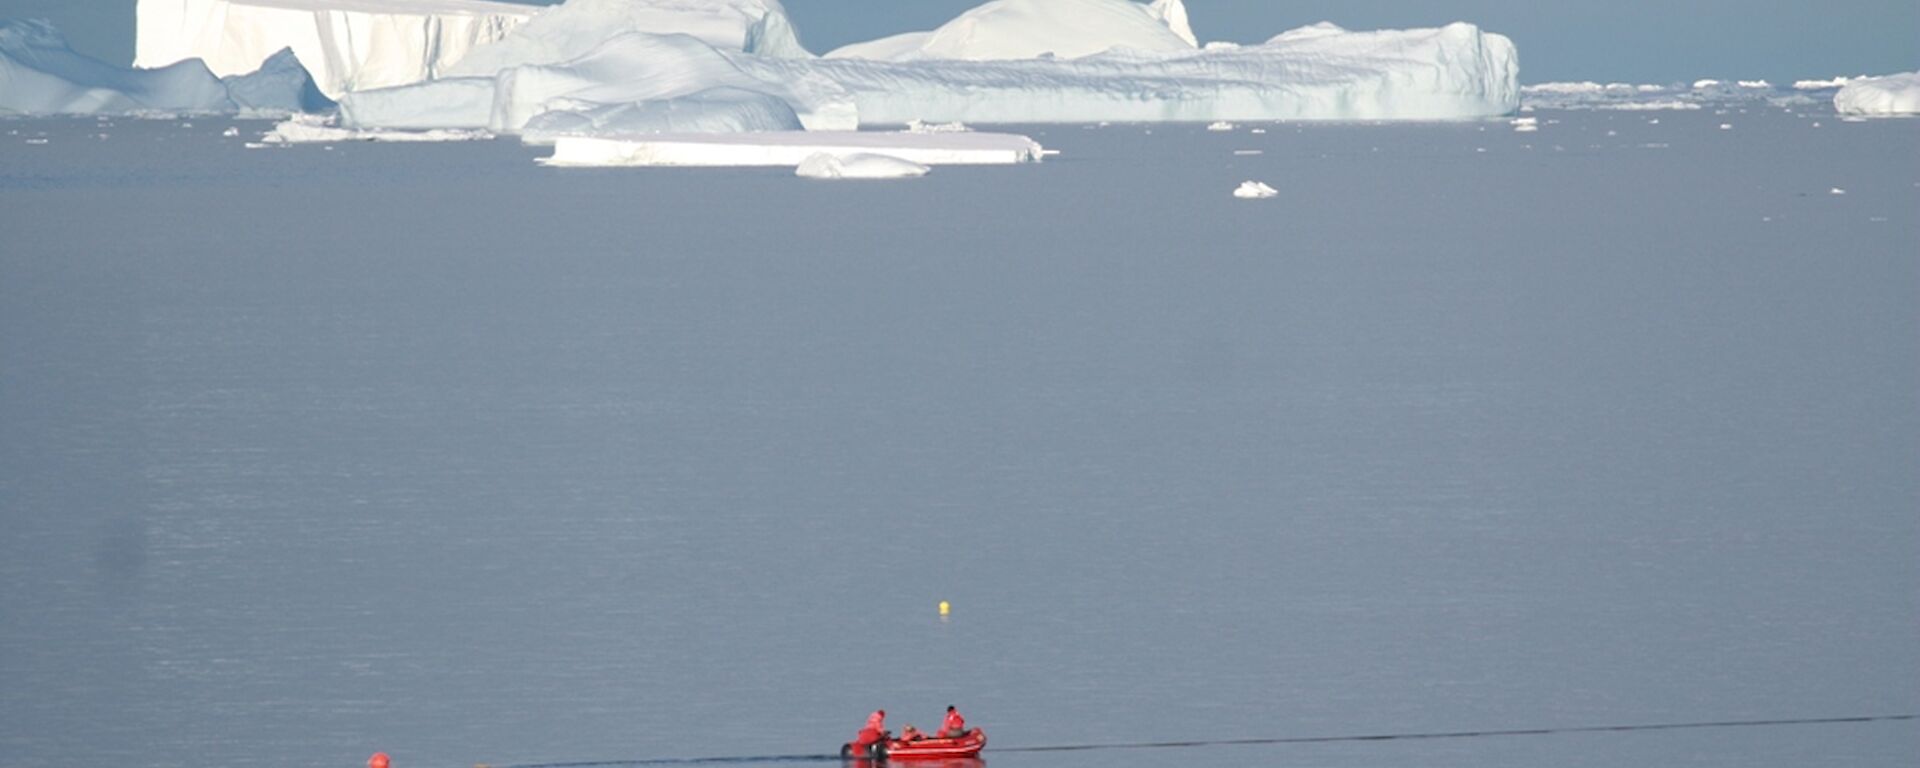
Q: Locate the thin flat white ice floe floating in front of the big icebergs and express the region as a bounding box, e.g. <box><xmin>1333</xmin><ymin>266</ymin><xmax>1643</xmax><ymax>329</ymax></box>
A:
<box><xmin>543</xmin><ymin>131</ymin><xmax>1046</xmax><ymax>167</ymax></box>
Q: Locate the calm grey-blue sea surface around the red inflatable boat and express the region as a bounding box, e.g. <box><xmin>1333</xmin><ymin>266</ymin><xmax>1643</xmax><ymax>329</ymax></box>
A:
<box><xmin>0</xmin><ymin>108</ymin><xmax>1920</xmax><ymax>768</ymax></box>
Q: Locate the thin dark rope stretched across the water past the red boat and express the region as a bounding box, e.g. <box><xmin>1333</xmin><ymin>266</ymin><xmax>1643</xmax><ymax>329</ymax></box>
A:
<box><xmin>488</xmin><ymin>714</ymin><xmax>1920</xmax><ymax>768</ymax></box>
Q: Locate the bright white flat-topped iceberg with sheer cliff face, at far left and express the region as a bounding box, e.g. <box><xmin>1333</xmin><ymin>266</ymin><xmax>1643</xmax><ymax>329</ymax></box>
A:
<box><xmin>134</xmin><ymin>0</ymin><xmax>540</xmax><ymax>98</ymax></box>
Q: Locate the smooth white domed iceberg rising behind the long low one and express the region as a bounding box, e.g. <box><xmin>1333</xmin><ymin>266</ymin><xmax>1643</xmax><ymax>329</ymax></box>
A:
<box><xmin>828</xmin><ymin>0</ymin><xmax>1198</xmax><ymax>61</ymax></box>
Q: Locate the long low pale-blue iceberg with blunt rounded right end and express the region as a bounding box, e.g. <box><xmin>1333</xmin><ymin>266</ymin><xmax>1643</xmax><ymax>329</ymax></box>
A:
<box><xmin>741</xmin><ymin>23</ymin><xmax>1519</xmax><ymax>125</ymax></box>
